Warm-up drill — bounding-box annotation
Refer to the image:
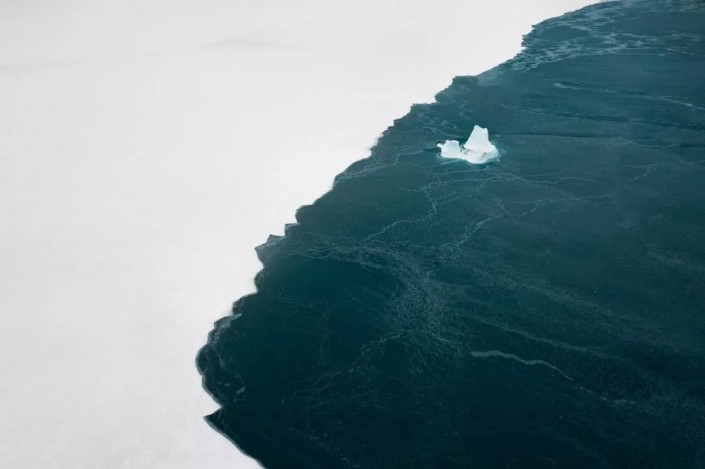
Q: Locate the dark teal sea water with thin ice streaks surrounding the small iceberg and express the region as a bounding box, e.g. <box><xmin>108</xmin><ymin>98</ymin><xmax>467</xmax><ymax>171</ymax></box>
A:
<box><xmin>198</xmin><ymin>0</ymin><xmax>705</xmax><ymax>468</ymax></box>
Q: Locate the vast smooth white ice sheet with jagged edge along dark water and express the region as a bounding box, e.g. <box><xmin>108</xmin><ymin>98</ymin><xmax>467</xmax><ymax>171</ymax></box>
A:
<box><xmin>0</xmin><ymin>0</ymin><xmax>594</xmax><ymax>469</ymax></box>
